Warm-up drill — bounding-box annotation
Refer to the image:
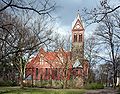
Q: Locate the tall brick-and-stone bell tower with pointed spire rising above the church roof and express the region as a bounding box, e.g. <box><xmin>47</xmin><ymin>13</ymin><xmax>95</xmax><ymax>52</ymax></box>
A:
<box><xmin>71</xmin><ymin>11</ymin><xmax>84</xmax><ymax>62</ymax></box>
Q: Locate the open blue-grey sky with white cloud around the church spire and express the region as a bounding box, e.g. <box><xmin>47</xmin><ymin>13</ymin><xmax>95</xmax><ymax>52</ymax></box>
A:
<box><xmin>54</xmin><ymin>0</ymin><xmax>99</xmax><ymax>36</ymax></box>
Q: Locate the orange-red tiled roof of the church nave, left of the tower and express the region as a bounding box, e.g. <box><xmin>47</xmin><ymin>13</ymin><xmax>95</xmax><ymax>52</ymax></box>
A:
<box><xmin>27</xmin><ymin>48</ymin><xmax>70</xmax><ymax>68</ymax></box>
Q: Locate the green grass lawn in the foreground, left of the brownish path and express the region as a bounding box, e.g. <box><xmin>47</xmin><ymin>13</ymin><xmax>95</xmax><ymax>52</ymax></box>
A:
<box><xmin>0</xmin><ymin>87</ymin><xmax>85</xmax><ymax>94</ymax></box>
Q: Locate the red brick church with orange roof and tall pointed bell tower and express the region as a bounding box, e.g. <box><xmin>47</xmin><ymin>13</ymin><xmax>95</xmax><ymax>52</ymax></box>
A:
<box><xmin>25</xmin><ymin>13</ymin><xmax>89</xmax><ymax>87</ymax></box>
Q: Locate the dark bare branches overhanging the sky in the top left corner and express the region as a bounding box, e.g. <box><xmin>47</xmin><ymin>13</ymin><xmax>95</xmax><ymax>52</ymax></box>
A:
<box><xmin>0</xmin><ymin>0</ymin><xmax>56</xmax><ymax>16</ymax></box>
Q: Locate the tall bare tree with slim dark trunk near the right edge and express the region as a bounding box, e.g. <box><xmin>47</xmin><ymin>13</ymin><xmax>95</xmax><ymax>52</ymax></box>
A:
<box><xmin>96</xmin><ymin>15</ymin><xmax>120</xmax><ymax>87</ymax></box>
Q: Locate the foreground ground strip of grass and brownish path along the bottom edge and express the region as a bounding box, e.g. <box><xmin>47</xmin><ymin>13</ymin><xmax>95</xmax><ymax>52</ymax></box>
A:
<box><xmin>0</xmin><ymin>87</ymin><xmax>120</xmax><ymax>94</ymax></box>
